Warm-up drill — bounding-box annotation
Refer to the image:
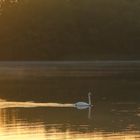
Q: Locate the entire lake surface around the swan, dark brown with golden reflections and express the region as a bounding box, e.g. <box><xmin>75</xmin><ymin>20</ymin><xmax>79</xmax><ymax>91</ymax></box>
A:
<box><xmin>0</xmin><ymin>61</ymin><xmax>140</xmax><ymax>140</ymax></box>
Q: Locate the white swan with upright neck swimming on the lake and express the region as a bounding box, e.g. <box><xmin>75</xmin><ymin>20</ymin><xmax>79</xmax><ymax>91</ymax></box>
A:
<box><xmin>74</xmin><ymin>92</ymin><xmax>93</xmax><ymax>109</ymax></box>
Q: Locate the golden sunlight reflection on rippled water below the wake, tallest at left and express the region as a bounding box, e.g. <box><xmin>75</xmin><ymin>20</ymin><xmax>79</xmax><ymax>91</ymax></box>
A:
<box><xmin>0</xmin><ymin>109</ymin><xmax>140</xmax><ymax>140</ymax></box>
